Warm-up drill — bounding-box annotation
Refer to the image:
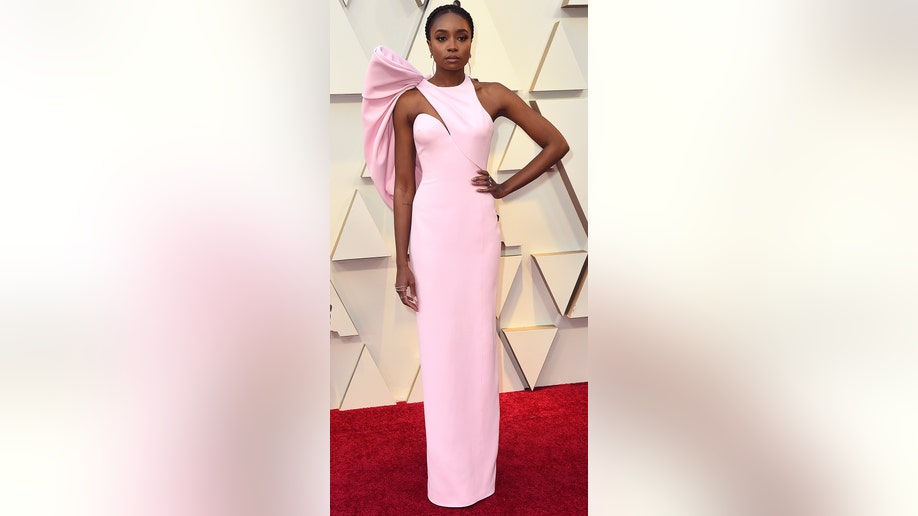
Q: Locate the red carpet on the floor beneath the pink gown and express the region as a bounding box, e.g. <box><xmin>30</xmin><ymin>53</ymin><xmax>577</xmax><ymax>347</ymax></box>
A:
<box><xmin>330</xmin><ymin>383</ymin><xmax>587</xmax><ymax>516</ymax></box>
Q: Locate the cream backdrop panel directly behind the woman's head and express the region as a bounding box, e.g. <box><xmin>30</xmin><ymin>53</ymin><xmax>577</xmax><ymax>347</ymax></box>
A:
<box><xmin>408</xmin><ymin>0</ymin><xmax>520</xmax><ymax>91</ymax></box>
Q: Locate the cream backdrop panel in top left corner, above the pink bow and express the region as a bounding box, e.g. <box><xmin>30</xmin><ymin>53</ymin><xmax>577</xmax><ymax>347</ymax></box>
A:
<box><xmin>328</xmin><ymin>0</ymin><xmax>370</xmax><ymax>95</ymax></box>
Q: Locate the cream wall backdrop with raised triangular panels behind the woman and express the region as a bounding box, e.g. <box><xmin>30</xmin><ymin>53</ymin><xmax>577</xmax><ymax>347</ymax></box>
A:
<box><xmin>328</xmin><ymin>0</ymin><xmax>588</xmax><ymax>410</ymax></box>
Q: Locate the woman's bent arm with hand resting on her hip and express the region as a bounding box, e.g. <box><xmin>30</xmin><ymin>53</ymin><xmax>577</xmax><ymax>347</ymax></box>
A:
<box><xmin>474</xmin><ymin>83</ymin><xmax>570</xmax><ymax>199</ymax></box>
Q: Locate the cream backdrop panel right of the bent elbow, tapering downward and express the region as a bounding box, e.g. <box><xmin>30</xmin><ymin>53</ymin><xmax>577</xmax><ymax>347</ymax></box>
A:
<box><xmin>532</xmin><ymin>98</ymin><xmax>589</xmax><ymax>231</ymax></box>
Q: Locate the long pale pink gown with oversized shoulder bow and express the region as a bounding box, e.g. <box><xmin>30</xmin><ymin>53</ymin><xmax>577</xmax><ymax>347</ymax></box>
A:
<box><xmin>362</xmin><ymin>47</ymin><xmax>500</xmax><ymax>507</ymax></box>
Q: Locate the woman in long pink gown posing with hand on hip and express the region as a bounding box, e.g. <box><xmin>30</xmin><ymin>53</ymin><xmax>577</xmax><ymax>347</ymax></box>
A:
<box><xmin>362</xmin><ymin>1</ymin><xmax>568</xmax><ymax>507</ymax></box>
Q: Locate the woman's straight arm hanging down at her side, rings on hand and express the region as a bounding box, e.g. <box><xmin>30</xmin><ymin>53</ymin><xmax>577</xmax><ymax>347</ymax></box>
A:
<box><xmin>392</xmin><ymin>91</ymin><xmax>418</xmax><ymax>311</ymax></box>
